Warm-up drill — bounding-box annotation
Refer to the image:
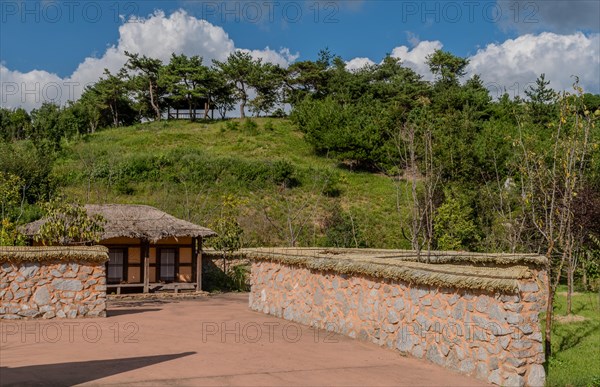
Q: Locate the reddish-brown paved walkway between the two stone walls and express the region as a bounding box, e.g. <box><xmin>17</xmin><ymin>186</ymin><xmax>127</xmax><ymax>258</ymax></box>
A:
<box><xmin>0</xmin><ymin>294</ymin><xmax>483</xmax><ymax>386</ymax></box>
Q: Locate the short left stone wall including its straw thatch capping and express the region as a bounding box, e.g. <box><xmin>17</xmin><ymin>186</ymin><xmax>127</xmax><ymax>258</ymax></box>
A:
<box><xmin>0</xmin><ymin>247</ymin><xmax>107</xmax><ymax>319</ymax></box>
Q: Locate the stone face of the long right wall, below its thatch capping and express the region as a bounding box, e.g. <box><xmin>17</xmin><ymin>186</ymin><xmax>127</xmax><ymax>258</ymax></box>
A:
<box><xmin>250</xmin><ymin>253</ymin><xmax>546</xmax><ymax>386</ymax></box>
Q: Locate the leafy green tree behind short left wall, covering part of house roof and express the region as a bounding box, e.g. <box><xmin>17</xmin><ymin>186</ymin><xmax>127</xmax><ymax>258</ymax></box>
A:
<box><xmin>34</xmin><ymin>198</ymin><xmax>106</xmax><ymax>245</ymax></box>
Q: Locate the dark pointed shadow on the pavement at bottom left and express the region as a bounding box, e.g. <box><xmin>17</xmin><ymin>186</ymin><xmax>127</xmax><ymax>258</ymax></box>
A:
<box><xmin>0</xmin><ymin>352</ymin><xmax>196</xmax><ymax>386</ymax></box>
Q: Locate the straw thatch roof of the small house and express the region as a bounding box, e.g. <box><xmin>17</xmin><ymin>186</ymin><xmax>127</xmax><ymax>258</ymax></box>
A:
<box><xmin>23</xmin><ymin>204</ymin><xmax>217</xmax><ymax>242</ymax></box>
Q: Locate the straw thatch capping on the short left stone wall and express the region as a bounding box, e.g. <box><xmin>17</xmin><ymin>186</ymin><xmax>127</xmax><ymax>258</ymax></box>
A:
<box><xmin>0</xmin><ymin>246</ymin><xmax>108</xmax><ymax>263</ymax></box>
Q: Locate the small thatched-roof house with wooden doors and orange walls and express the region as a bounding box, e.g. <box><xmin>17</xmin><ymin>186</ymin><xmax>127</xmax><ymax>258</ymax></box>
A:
<box><xmin>22</xmin><ymin>204</ymin><xmax>217</xmax><ymax>293</ymax></box>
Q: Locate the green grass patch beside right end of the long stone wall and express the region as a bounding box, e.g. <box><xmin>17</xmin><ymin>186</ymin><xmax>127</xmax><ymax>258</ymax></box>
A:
<box><xmin>547</xmin><ymin>287</ymin><xmax>600</xmax><ymax>386</ymax></box>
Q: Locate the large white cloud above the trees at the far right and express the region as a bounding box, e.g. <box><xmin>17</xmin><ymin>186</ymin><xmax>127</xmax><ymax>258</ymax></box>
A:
<box><xmin>467</xmin><ymin>32</ymin><xmax>600</xmax><ymax>97</ymax></box>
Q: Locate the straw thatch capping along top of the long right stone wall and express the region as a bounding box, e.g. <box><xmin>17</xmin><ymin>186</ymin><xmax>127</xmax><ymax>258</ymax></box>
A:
<box><xmin>243</xmin><ymin>248</ymin><xmax>543</xmax><ymax>292</ymax></box>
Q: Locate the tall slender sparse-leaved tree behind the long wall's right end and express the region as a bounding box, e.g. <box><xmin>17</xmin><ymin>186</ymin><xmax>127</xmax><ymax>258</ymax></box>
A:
<box><xmin>515</xmin><ymin>84</ymin><xmax>597</xmax><ymax>359</ymax></box>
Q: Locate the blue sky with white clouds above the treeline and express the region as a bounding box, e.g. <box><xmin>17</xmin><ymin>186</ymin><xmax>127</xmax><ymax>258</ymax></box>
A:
<box><xmin>0</xmin><ymin>0</ymin><xmax>600</xmax><ymax>110</ymax></box>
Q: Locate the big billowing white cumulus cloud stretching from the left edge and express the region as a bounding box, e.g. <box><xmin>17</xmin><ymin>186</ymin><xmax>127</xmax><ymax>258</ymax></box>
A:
<box><xmin>0</xmin><ymin>10</ymin><xmax>298</xmax><ymax>110</ymax></box>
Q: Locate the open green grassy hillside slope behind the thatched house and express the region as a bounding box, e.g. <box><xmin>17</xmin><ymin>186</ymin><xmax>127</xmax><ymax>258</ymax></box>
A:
<box><xmin>53</xmin><ymin>118</ymin><xmax>408</xmax><ymax>248</ymax></box>
